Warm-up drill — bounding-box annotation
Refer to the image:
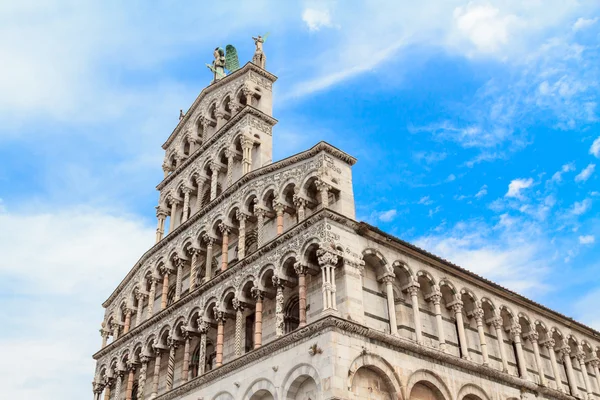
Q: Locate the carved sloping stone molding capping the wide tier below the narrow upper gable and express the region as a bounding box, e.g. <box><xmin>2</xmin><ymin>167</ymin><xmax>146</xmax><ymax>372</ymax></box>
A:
<box><xmin>102</xmin><ymin>142</ymin><xmax>356</xmax><ymax>308</ymax></box>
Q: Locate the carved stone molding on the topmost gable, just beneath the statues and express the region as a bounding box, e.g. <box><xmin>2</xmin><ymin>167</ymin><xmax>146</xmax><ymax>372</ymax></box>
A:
<box><xmin>162</xmin><ymin>62</ymin><xmax>277</xmax><ymax>150</ymax></box>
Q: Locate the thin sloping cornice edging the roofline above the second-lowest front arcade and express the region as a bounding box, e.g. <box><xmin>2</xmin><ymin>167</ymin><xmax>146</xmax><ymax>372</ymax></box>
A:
<box><xmin>102</xmin><ymin>145</ymin><xmax>356</xmax><ymax>308</ymax></box>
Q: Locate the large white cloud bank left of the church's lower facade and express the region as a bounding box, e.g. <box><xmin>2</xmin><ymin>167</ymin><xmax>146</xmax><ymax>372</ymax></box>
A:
<box><xmin>0</xmin><ymin>208</ymin><xmax>154</xmax><ymax>399</ymax></box>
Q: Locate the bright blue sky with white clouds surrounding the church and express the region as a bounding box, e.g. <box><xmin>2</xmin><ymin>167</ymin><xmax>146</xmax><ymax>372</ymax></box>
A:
<box><xmin>0</xmin><ymin>0</ymin><xmax>600</xmax><ymax>400</ymax></box>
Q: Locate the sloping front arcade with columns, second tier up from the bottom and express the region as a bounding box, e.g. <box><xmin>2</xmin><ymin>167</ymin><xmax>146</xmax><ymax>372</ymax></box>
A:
<box><xmin>102</xmin><ymin>171</ymin><xmax>339</xmax><ymax>347</ymax></box>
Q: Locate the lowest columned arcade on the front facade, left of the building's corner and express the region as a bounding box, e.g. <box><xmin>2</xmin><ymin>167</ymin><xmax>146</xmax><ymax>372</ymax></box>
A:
<box><xmin>95</xmin><ymin>239</ymin><xmax>341</xmax><ymax>400</ymax></box>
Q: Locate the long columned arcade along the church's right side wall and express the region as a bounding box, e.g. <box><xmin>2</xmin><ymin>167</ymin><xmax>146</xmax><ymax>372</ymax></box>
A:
<box><xmin>363</xmin><ymin>249</ymin><xmax>600</xmax><ymax>396</ymax></box>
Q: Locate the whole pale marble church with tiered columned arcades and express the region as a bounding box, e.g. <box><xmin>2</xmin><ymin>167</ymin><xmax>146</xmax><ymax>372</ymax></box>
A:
<box><xmin>93</xmin><ymin>41</ymin><xmax>600</xmax><ymax>400</ymax></box>
